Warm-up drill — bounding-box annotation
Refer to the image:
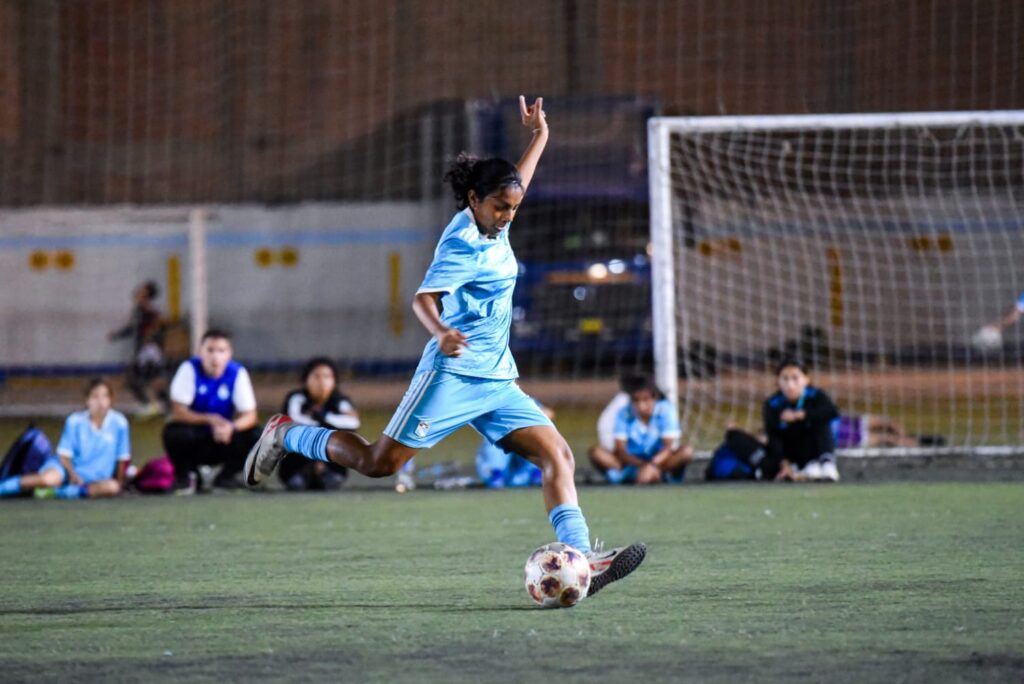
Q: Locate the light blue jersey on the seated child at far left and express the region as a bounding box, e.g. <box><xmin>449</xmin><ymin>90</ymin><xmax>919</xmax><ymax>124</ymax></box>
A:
<box><xmin>57</xmin><ymin>409</ymin><xmax>131</xmax><ymax>483</ymax></box>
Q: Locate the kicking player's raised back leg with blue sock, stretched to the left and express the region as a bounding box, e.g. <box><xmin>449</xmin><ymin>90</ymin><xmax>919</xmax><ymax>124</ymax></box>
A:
<box><xmin>245</xmin><ymin>414</ymin><xmax>418</xmax><ymax>486</ymax></box>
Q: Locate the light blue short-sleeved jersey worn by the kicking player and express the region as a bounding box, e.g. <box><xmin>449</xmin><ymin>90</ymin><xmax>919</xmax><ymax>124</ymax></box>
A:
<box><xmin>416</xmin><ymin>209</ymin><xmax>519</xmax><ymax>380</ymax></box>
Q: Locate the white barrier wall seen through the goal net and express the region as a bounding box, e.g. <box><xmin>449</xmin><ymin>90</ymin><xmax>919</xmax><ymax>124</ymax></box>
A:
<box><xmin>676</xmin><ymin>198</ymin><xmax>1024</xmax><ymax>355</ymax></box>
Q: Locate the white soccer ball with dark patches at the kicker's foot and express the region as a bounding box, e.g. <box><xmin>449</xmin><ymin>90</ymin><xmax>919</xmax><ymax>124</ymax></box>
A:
<box><xmin>523</xmin><ymin>542</ymin><xmax>590</xmax><ymax>608</ymax></box>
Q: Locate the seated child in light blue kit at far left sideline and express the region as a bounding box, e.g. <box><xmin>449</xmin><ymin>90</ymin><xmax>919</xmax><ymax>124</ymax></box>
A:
<box><xmin>0</xmin><ymin>380</ymin><xmax>131</xmax><ymax>499</ymax></box>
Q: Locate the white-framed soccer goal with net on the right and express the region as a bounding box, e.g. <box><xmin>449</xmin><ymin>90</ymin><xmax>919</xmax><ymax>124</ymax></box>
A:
<box><xmin>648</xmin><ymin>112</ymin><xmax>1024</xmax><ymax>455</ymax></box>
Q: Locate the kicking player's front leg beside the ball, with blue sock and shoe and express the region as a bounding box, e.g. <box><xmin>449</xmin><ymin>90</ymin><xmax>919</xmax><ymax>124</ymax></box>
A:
<box><xmin>501</xmin><ymin>425</ymin><xmax>647</xmax><ymax>596</ymax></box>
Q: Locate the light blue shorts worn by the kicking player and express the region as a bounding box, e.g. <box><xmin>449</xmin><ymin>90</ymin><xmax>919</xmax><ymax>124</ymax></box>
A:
<box><xmin>384</xmin><ymin>371</ymin><xmax>553</xmax><ymax>448</ymax></box>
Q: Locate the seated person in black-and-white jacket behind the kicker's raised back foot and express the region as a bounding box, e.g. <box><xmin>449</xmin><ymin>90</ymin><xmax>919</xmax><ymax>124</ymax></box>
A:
<box><xmin>278</xmin><ymin>357</ymin><xmax>359</xmax><ymax>491</ymax></box>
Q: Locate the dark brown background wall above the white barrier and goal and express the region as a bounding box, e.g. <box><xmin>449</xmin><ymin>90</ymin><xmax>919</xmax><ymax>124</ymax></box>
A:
<box><xmin>0</xmin><ymin>0</ymin><xmax>1024</xmax><ymax>206</ymax></box>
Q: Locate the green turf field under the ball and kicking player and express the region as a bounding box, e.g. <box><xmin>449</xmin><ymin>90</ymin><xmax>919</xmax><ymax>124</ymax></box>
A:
<box><xmin>0</xmin><ymin>483</ymin><xmax>1024</xmax><ymax>682</ymax></box>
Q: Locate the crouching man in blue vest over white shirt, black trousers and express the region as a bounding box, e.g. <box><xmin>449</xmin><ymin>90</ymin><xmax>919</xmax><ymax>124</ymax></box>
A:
<box><xmin>163</xmin><ymin>330</ymin><xmax>259</xmax><ymax>494</ymax></box>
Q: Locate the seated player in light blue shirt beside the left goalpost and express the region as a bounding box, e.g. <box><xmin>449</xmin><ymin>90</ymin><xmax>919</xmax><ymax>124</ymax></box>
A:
<box><xmin>591</xmin><ymin>380</ymin><xmax>693</xmax><ymax>484</ymax></box>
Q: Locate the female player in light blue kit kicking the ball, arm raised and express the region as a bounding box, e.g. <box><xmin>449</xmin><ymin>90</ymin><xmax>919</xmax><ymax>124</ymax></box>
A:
<box><xmin>245</xmin><ymin>96</ymin><xmax>646</xmax><ymax>594</ymax></box>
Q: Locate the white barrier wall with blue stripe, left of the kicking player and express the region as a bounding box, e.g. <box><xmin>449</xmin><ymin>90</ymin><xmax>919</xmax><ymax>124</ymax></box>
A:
<box><xmin>0</xmin><ymin>203</ymin><xmax>449</xmax><ymax>367</ymax></box>
